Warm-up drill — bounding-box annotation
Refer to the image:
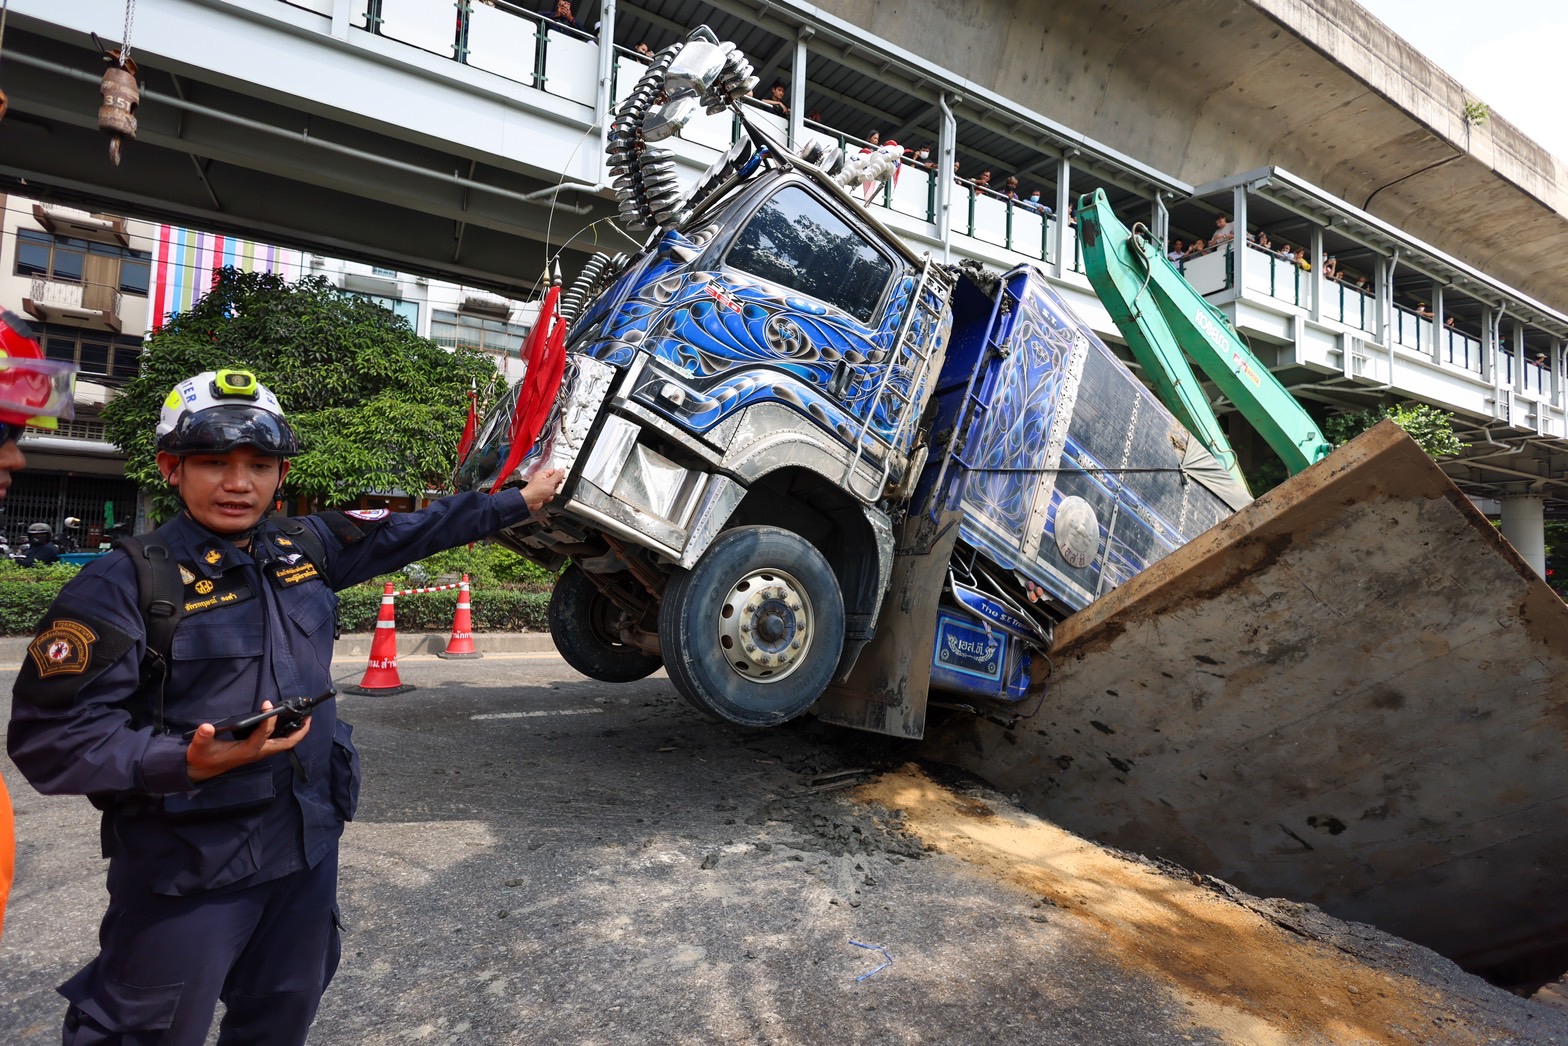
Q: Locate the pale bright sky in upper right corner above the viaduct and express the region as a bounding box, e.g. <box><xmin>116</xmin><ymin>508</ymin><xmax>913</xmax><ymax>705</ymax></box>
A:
<box><xmin>1359</xmin><ymin>0</ymin><xmax>1568</xmax><ymax>162</ymax></box>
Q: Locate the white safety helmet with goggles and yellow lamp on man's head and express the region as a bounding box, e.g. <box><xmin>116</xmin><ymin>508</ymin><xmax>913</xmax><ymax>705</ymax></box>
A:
<box><xmin>158</xmin><ymin>370</ymin><xmax>299</xmax><ymax>458</ymax></box>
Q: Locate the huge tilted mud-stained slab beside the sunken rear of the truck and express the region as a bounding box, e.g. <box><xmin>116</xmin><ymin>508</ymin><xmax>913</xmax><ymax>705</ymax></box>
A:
<box><xmin>911</xmin><ymin>422</ymin><xmax>1568</xmax><ymax>975</ymax></box>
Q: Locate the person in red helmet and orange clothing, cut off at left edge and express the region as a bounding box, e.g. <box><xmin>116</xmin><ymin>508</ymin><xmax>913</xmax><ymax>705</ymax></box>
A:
<box><xmin>0</xmin><ymin>309</ymin><xmax>77</xmax><ymax>933</ymax></box>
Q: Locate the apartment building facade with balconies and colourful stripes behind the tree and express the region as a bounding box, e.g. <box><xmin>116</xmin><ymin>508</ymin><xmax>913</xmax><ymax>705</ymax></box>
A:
<box><xmin>0</xmin><ymin>196</ymin><xmax>538</xmax><ymax>549</ymax></box>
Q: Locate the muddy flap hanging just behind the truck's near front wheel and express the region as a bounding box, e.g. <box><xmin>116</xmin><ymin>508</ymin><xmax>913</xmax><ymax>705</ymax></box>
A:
<box><xmin>812</xmin><ymin>510</ymin><xmax>958</xmax><ymax>737</ymax></box>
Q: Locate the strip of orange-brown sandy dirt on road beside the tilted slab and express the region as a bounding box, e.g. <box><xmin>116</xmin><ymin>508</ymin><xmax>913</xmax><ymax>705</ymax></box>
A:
<box><xmin>853</xmin><ymin>765</ymin><xmax>1565</xmax><ymax>1046</ymax></box>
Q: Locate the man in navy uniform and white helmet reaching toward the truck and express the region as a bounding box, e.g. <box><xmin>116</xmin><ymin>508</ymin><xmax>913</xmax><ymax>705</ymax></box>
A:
<box><xmin>8</xmin><ymin>370</ymin><xmax>561</xmax><ymax>1046</ymax></box>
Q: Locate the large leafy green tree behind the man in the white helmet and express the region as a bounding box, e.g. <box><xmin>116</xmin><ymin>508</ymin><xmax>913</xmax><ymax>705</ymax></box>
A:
<box><xmin>103</xmin><ymin>268</ymin><xmax>495</xmax><ymax>514</ymax></box>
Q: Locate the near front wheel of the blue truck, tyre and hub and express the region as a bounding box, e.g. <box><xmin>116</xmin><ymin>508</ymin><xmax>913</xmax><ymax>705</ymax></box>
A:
<box><xmin>659</xmin><ymin>527</ymin><xmax>844</xmax><ymax>726</ymax></box>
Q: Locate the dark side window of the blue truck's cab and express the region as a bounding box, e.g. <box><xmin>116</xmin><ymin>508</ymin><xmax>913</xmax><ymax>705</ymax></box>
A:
<box><xmin>726</xmin><ymin>185</ymin><xmax>892</xmax><ymax>323</ymax></box>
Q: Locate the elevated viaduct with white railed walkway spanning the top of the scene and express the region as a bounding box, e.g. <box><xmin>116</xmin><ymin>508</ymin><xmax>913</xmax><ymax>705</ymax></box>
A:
<box><xmin>0</xmin><ymin>0</ymin><xmax>1568</xmax><ymax>547</ymax></box>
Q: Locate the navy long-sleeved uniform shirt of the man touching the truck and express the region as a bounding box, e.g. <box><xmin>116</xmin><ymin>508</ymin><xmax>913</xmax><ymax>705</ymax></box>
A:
<box><xmin>6</xmin><ymin>489</ymin><xmax>528</xmax><ymax>895</ymax></box>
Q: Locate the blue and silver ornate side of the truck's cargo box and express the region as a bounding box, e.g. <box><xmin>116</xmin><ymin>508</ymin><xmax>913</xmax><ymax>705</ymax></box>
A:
<box><xmin>933</xmin><ymin>267</ymin><xmax>1231</xmax><ymax>613</ymax></box>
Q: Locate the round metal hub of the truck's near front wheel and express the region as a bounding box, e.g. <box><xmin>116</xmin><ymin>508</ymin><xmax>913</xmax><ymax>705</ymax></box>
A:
<box><xmin>718</xmin><ymin>569</ymin><xmax>812</xmax><ymax>682</ymax></box>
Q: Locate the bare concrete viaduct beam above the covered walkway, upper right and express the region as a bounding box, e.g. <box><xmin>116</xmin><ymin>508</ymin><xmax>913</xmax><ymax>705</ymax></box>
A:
<box><xmin>840</xmin><ymin>0</ymin><xmax>1568</xmax><ymax>309</ymax></box>
